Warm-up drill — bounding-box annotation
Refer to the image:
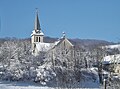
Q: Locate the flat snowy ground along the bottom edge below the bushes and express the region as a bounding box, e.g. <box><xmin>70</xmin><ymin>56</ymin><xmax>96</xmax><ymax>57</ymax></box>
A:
<box><xmin>0</xmin><ymin>81</ymin><xmax>99</xmax><ymax>89</ymax></box>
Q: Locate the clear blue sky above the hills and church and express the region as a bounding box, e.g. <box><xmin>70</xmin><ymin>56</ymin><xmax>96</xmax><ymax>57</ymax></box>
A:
<box><xmin>0</xmin><ymin>0</ymin><xmax>120</xmax><ymax>42</ymax></box>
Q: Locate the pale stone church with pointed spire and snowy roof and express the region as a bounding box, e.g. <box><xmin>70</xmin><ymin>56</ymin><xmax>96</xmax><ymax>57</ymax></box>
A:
<box><xmin>31</xmin><ymin>11</ymin><xmax>74</xmax><ymax>56</ymax></box>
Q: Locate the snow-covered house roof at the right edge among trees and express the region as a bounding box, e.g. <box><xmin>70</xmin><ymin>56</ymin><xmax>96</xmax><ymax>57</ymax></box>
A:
<box><xmin>103</xmin><ymin>54</ymin><xmax>120</xmax><ymax>64</ymax></box>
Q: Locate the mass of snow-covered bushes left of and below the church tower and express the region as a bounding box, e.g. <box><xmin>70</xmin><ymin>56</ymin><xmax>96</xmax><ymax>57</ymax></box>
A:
<box><xmin>0</xmin><ymin>39</ymin><xmax>55</xmax><ymax>84</ymax></box>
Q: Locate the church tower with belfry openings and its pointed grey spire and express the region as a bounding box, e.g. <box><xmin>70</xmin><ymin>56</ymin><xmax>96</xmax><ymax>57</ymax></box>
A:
<box><xmin>31</xmin><ymin>10</ymin><xmax>44</xmax><ymax>53</ymax></box>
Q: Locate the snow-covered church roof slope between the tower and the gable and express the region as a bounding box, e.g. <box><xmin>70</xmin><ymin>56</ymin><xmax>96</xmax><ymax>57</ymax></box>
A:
<box><xmin>36</xmin><ymin>42</ymin><xmax>53</xmax><ymax>52</ymax></box>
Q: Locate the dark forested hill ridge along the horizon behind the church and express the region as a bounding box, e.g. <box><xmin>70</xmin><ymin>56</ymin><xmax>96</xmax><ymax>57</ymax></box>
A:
<box><xmin>0</xmin><ymin>36</ymin><xmax>115</xmax><ymax>46</ymax></box>
